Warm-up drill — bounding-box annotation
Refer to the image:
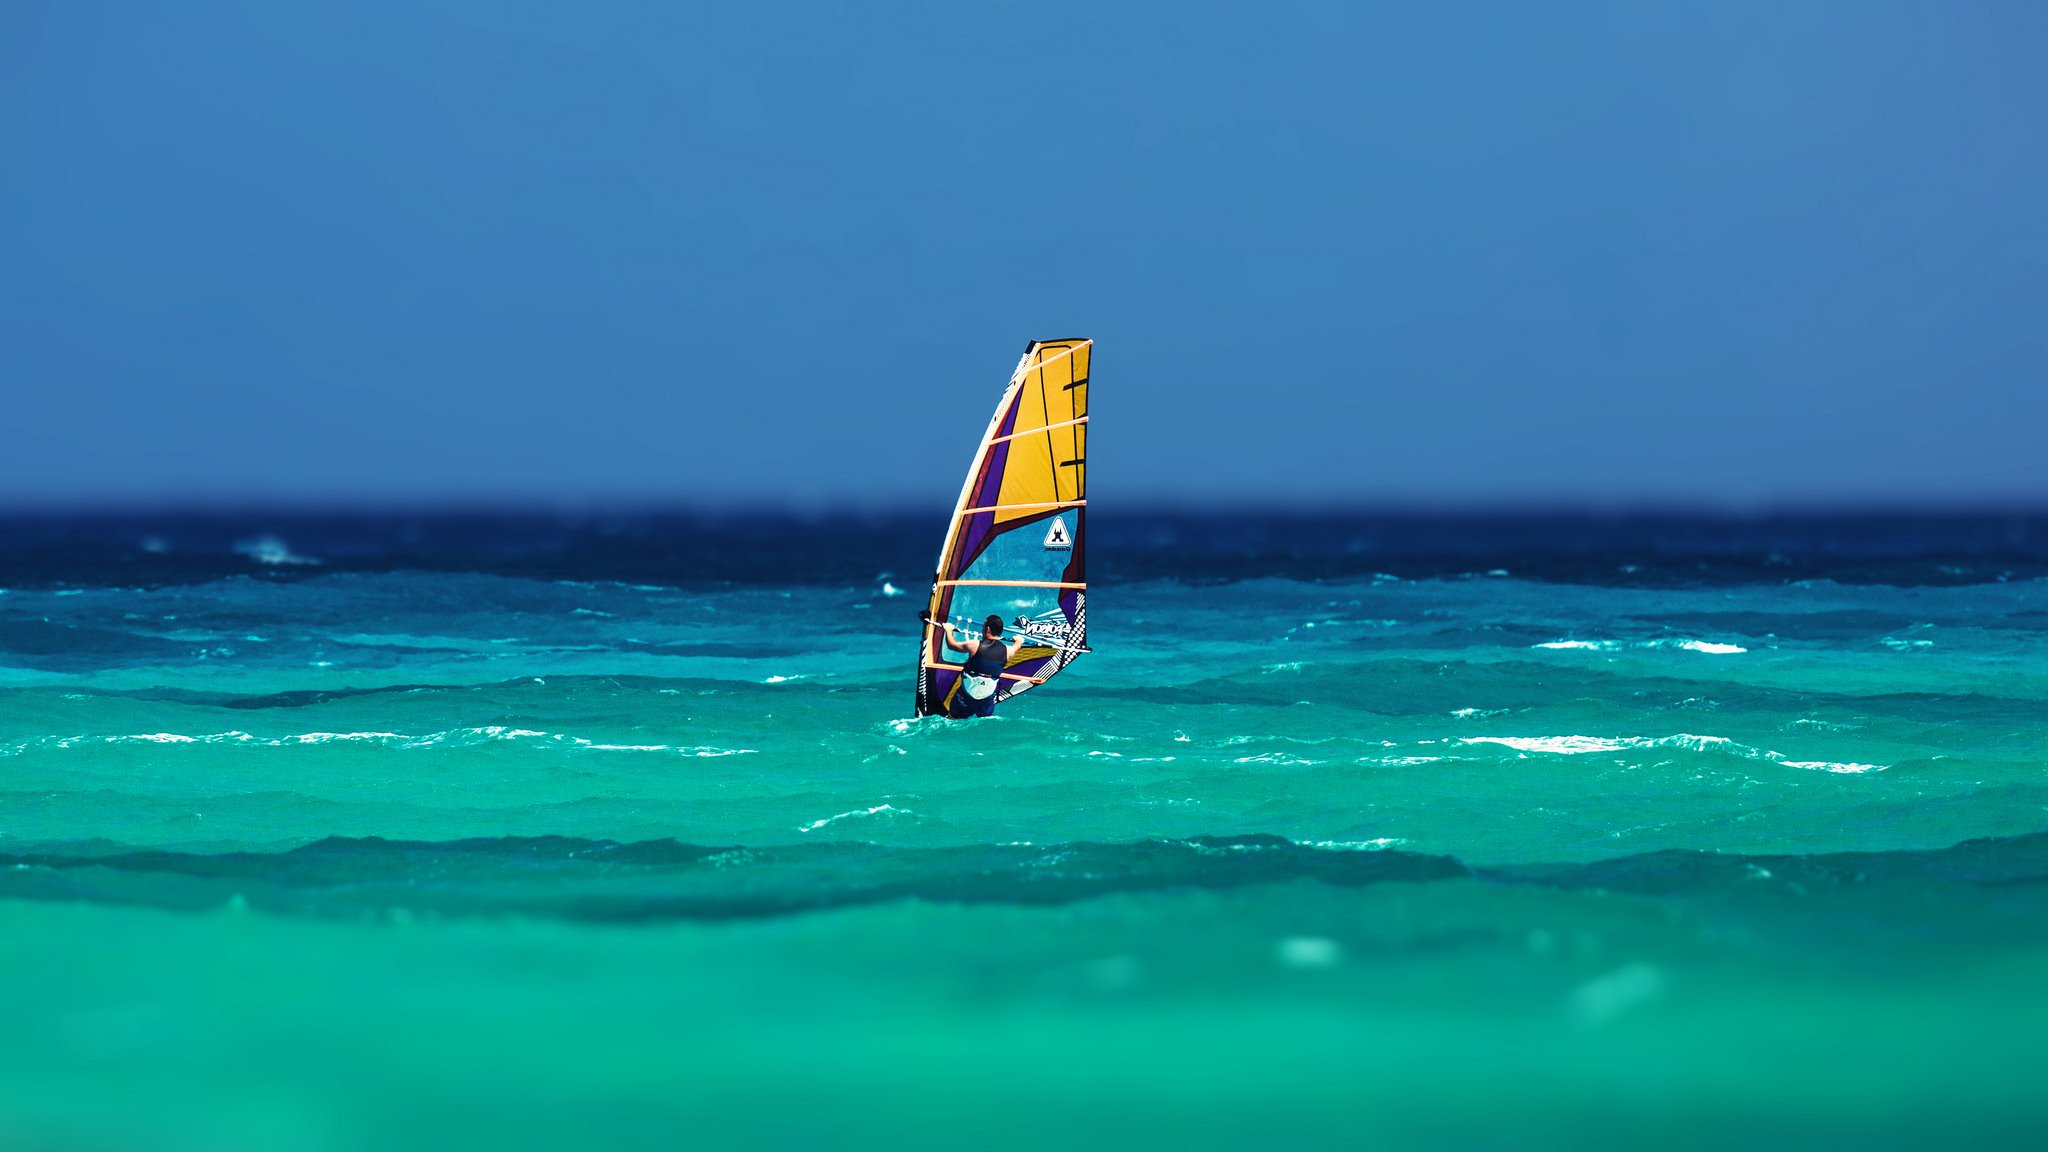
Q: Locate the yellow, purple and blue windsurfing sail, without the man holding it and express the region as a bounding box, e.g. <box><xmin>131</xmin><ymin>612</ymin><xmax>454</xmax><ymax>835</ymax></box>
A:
<box><xmin>918</xmin><ymin>332</ymin><xmax>1094</xmax><ymax>715</ymax></box>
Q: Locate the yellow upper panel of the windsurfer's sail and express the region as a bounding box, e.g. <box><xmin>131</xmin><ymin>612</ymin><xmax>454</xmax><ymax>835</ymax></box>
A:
<box><xmin>995</xmin><ymin>340</ymin><xmax>1092</xmax><ymax>525</ymax></box>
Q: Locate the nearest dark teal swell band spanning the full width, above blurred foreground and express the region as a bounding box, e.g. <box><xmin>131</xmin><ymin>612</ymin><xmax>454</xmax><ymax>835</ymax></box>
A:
<box><xmin>0</xmin><ymin>824</ymin><xmax>2048</xmax><ymax>922</ymax></box>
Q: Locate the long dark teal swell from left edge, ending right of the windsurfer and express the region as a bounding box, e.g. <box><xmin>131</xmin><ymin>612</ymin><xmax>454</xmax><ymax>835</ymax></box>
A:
<box><xmin>0</xmin><ymin>828</ymin><xmax>1470</xmax><ymax>922</ymax></box>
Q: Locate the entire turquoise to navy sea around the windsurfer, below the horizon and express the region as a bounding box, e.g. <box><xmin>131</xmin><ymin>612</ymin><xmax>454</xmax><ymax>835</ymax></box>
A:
<box><xmin>0</xmin><ymin>510</ymin><xmax>2048</xmax><ymax>1152</ymax></box>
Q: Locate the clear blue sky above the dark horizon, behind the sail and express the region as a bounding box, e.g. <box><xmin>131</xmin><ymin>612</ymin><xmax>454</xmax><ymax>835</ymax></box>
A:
<box><xmin>0</xmin><ymin>0</ymin><xmax>2048</xmax><ymax>504</ymax></box>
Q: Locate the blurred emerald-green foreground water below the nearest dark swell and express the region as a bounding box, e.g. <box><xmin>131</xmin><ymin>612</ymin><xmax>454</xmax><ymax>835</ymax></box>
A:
<box><xmin>0</xmin><ymin>881</ymin><xmax>2048</xmax><ymax>1148</ymax></box>
